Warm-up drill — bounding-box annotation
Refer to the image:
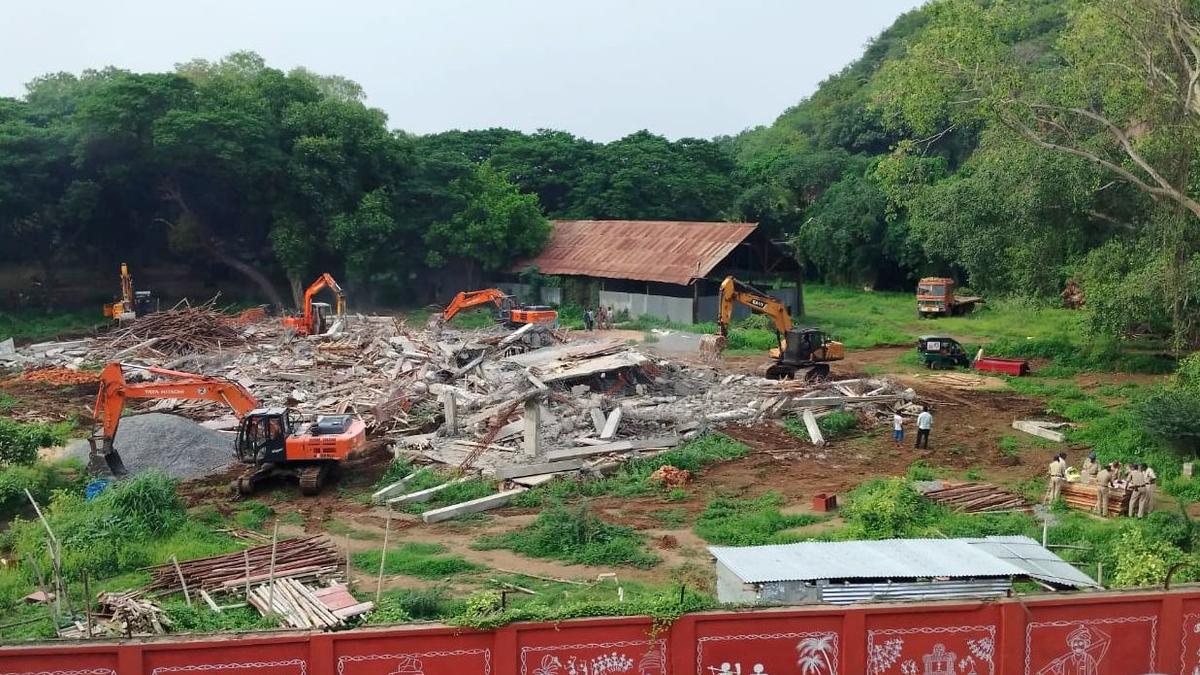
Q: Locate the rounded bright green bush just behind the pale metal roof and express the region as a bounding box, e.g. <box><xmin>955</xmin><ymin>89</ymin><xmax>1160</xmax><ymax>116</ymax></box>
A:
<box><xmin>842</xmin><ymin>478</ymin><xmax>935</xmax><ymax>539</ymax></box>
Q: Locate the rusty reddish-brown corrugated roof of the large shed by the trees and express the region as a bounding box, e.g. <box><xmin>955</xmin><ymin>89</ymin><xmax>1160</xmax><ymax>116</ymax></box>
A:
<box><xmin>512</xmin><ymin>220</ymin><xmax>758</xmax><ymax>285</ymax></box>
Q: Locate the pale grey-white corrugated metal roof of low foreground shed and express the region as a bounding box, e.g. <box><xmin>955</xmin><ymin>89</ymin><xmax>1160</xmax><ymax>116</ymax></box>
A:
<box><xmin>708</xmin><ymin>537</ymin><xmax>1094</xmax><ymax>585</ymax></box>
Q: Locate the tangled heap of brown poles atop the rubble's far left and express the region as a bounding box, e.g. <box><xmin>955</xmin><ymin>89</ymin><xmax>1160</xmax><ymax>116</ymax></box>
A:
<box><xmin>92</xmin><ymin>298</ymin><xmax>245</xmax><ymax>360</ymax></box>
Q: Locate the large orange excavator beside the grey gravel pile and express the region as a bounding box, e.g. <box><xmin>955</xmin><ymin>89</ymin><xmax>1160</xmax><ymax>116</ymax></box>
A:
<box><xmin>88</xmin><ymin>363</ymin><xmax>366</xmax><ymax>495</ymax></box>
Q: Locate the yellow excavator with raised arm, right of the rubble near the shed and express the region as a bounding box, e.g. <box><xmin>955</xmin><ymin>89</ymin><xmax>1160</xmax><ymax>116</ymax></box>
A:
<box><xmin>702</xmin><ymin>276</ymin><xmax>846</xmax><ymax>382</ymax></box>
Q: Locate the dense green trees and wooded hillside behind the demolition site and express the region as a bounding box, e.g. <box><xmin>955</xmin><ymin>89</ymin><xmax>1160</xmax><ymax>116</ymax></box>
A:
<box><xmin>0</xmin><ymin>0</ymin><xmax>1200</xmax><ymax>342</ymax></box>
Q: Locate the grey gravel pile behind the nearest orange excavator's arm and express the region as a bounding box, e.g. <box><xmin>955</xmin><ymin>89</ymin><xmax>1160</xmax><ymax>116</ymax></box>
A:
<box><xmin>66</xmin><ymin>413</ymin><xmax>235</xmax><ymax>478</ymax></box>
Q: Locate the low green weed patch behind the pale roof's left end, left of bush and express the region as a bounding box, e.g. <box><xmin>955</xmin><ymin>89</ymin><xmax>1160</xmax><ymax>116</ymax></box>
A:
<box><xmin>692</xmin><ymin>492</ymin><xmax>823</xmax><ymax>546</ymax></box>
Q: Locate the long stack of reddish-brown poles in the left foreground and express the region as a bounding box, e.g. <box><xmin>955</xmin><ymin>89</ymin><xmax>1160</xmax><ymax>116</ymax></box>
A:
<box><xmin>146</xmin><ymin>536</ymin><xmax>341</xmax><ymax>593</ymax></box>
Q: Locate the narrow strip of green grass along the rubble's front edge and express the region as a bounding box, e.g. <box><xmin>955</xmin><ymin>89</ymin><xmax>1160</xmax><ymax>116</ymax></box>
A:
<box><xmin>511</xmin><ymin>434</ymin><xmax>750</xmax><ymax>508</ymax></box>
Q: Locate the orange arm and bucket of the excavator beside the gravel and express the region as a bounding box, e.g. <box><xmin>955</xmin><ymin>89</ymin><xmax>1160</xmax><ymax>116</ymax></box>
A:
<box><xmin>88</xmin><ymin>363</ymin><xmax>258</xmax><ymax>476</ymax></box>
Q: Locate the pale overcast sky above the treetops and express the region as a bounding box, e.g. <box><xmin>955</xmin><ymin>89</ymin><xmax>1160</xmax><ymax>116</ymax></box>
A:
<box><xmin>0</xmin><ymin>0</ymin><xmax>922</xmax><ymax>141</ymax></box>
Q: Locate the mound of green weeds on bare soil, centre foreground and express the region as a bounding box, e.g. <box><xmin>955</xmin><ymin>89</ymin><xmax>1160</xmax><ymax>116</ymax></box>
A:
<box><xmin>475</xmin><ymin>504</ymin><xmax>659</xmax><ymax>568</ymax></box>
